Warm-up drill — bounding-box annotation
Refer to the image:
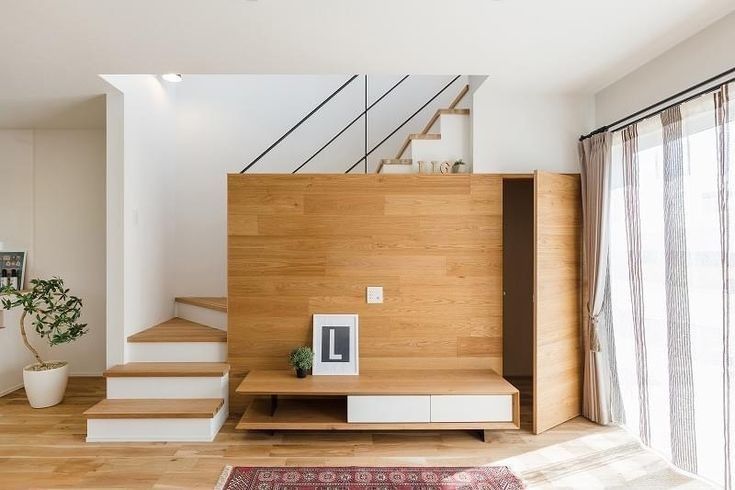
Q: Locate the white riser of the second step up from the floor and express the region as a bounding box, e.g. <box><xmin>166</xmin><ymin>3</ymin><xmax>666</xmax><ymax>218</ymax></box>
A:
<box><xmin>107</xmin><ymin>375</ymin><xmax>229</xmax><ymax>401</ymax></box>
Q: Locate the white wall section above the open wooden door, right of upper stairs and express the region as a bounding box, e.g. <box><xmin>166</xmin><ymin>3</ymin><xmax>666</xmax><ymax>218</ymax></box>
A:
<box><xmin>472</xmin><ymin>78</ymin><xmax>594</xmax><ymax>173</ymax></box>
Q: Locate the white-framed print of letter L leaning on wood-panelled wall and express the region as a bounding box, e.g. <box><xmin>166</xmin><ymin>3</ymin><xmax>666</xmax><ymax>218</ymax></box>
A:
<box><xmin>312</xmin><ymin>314</ymin><xmax>360</xmax><ymax>375</ymax></box>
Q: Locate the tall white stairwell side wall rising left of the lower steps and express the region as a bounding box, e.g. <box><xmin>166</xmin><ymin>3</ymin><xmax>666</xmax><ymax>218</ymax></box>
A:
<box><xmin>104</xmin><ymin>75</ymin><xmax>177</xmax><ymax>348</ymax></box>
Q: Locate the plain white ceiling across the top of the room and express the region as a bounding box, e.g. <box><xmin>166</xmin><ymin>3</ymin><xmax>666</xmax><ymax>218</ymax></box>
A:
<box><xmin>0</xmin><ymin>0</ymin><xmax>735</xmax><ymax>128</ymax></box>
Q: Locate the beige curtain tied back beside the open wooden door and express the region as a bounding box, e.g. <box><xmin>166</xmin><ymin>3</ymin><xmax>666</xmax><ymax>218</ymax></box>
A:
<box><xmin>579</xmin><ymin>131</ymin><xmax>612</xmax><ymax>424</ymax></box>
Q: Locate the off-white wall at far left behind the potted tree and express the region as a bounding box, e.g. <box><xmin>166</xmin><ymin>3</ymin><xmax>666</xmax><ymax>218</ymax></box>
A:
<box><xmin>0</xmin><ymin>130</ymin><xmax>106</xmax><ymax>393</ymax></box>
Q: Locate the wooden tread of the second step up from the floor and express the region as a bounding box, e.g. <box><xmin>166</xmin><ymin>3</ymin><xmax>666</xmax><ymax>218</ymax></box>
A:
<box><xmin>103</xmin><ymin>362</ymin><xmax>230</xmax><ymax>378</ymax></box>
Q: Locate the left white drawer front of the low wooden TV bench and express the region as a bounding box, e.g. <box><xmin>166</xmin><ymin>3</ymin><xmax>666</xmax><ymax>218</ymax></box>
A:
<box><xmin>347</xmin><ymin>395</ymin><xmax>431</xmax><ymax>423</ymax></box>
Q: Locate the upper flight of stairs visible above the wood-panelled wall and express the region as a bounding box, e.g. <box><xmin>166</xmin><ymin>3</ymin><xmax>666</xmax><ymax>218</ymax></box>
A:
<box><xmin>378</xmin><ymin>85</ymin><xmax>472</xmax><ymax>174</ymax></box>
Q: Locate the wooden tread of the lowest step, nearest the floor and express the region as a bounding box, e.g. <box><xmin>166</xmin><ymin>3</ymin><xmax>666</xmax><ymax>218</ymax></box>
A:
<box><xmin>84</xmin><ymin>398</ymin><xmax>225</xmax><ymax>419</ymax></box>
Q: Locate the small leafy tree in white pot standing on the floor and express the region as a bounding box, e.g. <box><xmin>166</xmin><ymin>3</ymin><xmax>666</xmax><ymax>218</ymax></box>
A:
<box><xmin>0</xmin><ymin>277</ymin><xmax>87</xmax><ymax>408</ymax></box>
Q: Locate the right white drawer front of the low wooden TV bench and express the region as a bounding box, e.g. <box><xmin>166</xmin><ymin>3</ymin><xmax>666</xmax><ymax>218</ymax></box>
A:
<box><xmin>431</xmin><ymin>395</ymin><xmax>513</xmax><ymax>422</ymax></box>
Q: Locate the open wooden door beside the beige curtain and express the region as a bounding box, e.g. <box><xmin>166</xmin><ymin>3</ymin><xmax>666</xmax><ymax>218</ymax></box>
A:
<box><xmin>533</xmin><ymin>171</ymin><xmax>582</xmax><ymax>434</ymax></box>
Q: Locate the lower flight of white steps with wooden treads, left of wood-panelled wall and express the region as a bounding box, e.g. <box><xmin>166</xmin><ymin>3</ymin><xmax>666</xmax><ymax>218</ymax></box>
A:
<box><xmin>84</xmin><ymin>297</ymin><xmax>230</xmax><ymax>442</ymax></box>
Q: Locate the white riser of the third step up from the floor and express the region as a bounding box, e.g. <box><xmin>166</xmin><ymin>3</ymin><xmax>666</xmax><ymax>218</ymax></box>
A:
<box><xmin>127</xmin><ymin>342</ymin><xmax>227</xmax><ymax>362</ymax></box>
